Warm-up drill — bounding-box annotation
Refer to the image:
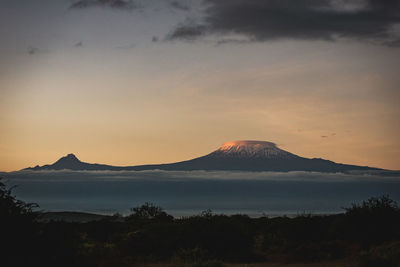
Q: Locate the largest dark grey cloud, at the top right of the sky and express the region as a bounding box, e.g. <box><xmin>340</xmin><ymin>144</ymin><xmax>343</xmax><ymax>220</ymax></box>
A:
<box><xmin>168</xmin><ymin>0</ymin><xmax>400</xmax><ymax>46</ymax></box>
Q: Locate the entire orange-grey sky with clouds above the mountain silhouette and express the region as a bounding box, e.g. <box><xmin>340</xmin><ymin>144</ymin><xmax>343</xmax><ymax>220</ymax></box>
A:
<box><xmin>0</xmin><ymin>0</ymin><xmax>400</xmax><ymax>171</ymax></box>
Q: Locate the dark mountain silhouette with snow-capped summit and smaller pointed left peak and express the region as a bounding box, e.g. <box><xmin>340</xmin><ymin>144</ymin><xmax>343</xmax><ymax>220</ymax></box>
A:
<box><xmin>23</xmin><ymin>140</ymin><xmax>379</xmax><ymax>172</ymax></box>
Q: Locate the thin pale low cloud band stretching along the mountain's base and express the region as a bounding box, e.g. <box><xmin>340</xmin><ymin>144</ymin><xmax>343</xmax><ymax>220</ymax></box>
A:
<box><xmin>2</xmin><ymin>170</ymin><xmax>400</xmax><ymax>182</ymax></box>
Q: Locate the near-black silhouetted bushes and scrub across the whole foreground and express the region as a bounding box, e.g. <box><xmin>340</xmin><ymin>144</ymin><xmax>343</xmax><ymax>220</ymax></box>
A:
<box><xmin>0</xmin><ymin>181</ymin><xmax>400</xmax><ymax>267</ymax></box>
